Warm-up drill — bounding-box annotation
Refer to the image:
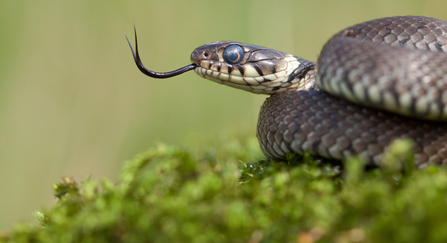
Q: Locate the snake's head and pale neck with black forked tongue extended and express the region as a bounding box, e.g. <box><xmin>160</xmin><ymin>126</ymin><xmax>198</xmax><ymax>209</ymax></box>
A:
<box><xmin>126</xmin><ymin>27</ymin><xmax>315</xmax><ymax>94</ymax></box>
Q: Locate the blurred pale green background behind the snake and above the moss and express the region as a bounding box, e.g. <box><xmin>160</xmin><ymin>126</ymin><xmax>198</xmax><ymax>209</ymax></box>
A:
<box><xmin>0</xmin><ymin>0</ymin><xmax>447</xmax><ymax>231</ymax></box>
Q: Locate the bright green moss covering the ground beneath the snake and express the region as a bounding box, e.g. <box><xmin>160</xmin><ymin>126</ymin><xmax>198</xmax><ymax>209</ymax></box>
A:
<box><xmin>0</xmin><ymin>140</ymin><xmax>447</xmax><ymax>243</ymax></box>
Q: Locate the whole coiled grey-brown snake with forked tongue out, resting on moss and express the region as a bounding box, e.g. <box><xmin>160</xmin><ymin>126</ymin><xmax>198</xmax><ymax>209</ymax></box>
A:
<box><xmin>126</xmin><ymin>16</ymin><xmax>447</xmax><ymax>168</ymax></box>
